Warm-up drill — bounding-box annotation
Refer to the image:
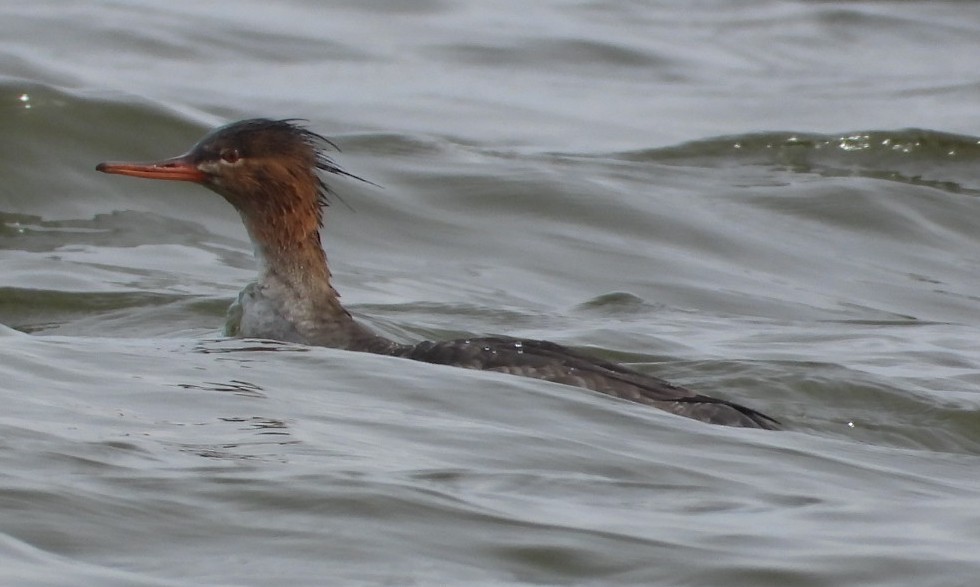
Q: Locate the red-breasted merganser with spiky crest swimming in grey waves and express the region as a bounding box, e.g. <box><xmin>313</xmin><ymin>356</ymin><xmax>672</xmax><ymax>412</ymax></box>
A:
<box><xmin>96</xmin><ymin>119</ymin><xmax>779</xmax><ymax>429</ymax></box>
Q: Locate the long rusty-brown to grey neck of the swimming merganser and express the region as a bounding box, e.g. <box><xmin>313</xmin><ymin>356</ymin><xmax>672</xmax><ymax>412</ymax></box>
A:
<box><xmin>236</xmin><ymin>184</ymin><xmax>398</xmax><ymax>354</ymax></box>
